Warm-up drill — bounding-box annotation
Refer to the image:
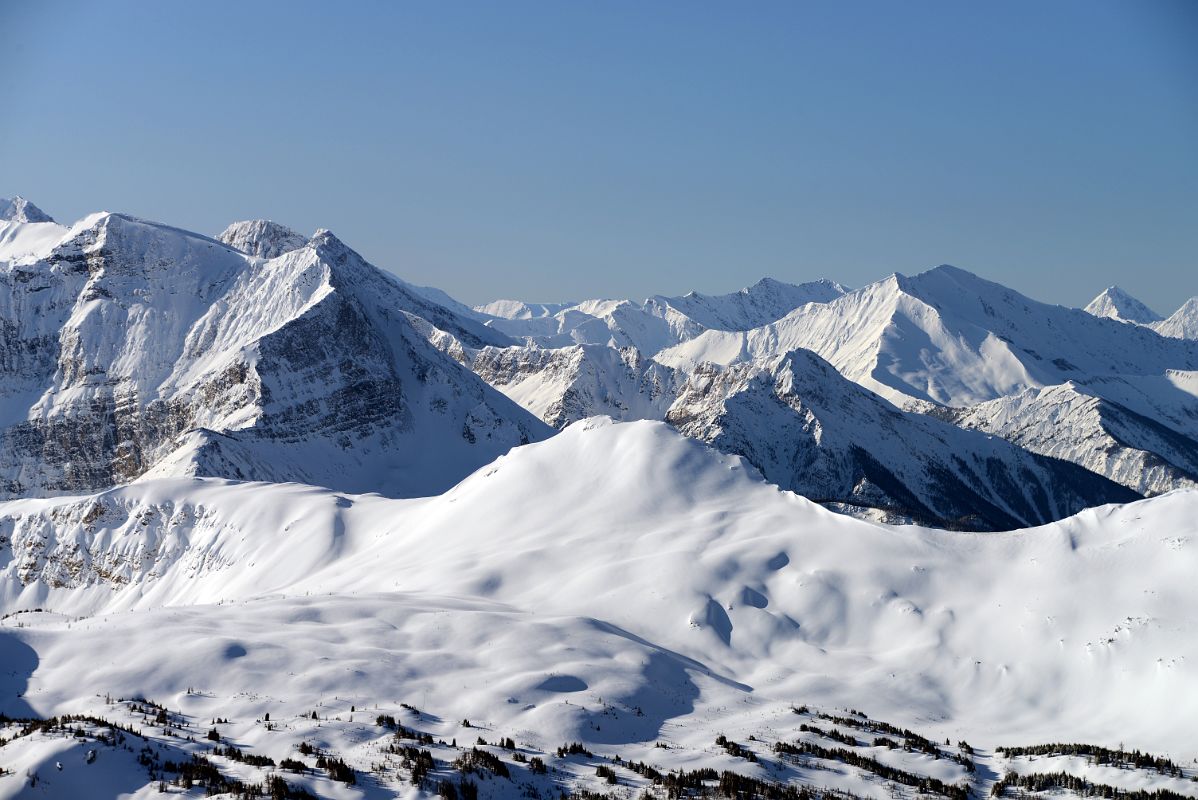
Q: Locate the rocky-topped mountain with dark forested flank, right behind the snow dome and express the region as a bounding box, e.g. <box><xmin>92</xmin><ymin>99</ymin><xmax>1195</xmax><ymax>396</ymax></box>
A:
<box><xmin>666</xmin><ymin>350</ymin><xmax>1138</xmax><ymax>531</ymax></box>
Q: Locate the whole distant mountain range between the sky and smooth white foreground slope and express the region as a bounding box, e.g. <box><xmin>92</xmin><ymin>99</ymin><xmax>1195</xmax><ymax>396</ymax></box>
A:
<box><xmin>0</xmin><ymin>198</ymin><xmax>1198</xmax><ymax>529</ymax></box>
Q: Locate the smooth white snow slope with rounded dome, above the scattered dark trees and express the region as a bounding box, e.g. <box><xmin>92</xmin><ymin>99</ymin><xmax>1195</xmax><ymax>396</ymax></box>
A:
<box><xmin>0</xmin><ymin>420</ymin><xmax>1198</xmax><ymax>776</ymax></box>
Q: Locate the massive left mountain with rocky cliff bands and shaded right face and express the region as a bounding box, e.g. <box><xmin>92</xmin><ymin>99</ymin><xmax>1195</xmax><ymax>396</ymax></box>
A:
<box><xmin>0</xmin><ymin>213</ymin><xmax>549</xmax><ymax>496</ymax></box>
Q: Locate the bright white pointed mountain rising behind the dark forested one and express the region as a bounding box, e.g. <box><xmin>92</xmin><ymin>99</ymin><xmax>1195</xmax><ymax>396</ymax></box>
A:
<box><xmin>655</xmin><ymin>266</ymin><xmax>1198</xmax><ymax>406</ymax></box>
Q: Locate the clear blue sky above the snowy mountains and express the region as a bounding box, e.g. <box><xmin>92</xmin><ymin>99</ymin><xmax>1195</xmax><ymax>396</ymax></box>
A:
<box><xmin>0</xmin><ymin>0</ymin><xmax>1198</xmax><ymax>313</ymax></box>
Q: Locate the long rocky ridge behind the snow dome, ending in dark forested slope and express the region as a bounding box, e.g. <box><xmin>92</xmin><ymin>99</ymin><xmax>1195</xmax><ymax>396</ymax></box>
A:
<box><xmin>425</xmin><ymin>331</ymin><xmax>1140</xmax><ymax>529</ymax></box>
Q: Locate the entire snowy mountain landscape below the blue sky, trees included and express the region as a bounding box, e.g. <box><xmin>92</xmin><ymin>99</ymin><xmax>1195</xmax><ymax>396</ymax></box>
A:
<box><xmin>0</xmin><ymin>198</ymin><xmax>1198</xmax><ymax>800</ymax></box>
